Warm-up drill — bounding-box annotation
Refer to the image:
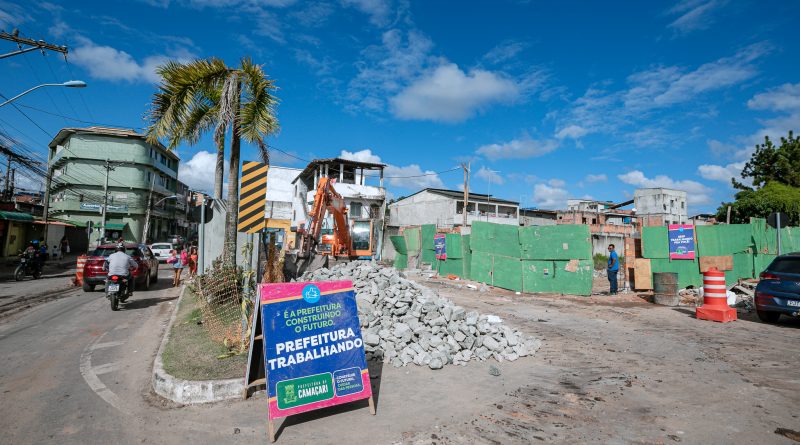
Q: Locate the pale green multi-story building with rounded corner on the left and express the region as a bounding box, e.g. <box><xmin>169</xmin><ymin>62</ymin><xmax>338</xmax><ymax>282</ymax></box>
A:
<box><xmin>48</xmin><ymin>127</ymin><xmax>180</xmax><ymax>245</ymax></box>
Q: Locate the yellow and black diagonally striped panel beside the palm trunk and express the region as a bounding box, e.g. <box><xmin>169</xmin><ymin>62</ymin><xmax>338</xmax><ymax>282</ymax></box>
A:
<box><xmin>237</xmin><ymin>161</ymin><xmax>269</xmax><ymax>233</ymax></box>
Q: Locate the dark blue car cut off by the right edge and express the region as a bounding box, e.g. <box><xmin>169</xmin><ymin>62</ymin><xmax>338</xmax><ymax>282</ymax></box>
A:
<box><xmin>755</xmin><ymin>252</ymin><xmax>800</xmax><ymax>323</ymax></box>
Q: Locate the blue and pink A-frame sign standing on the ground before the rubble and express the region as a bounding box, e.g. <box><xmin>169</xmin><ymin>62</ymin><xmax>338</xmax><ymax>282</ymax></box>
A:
<box><xmin>259</xmin><ymin>281</ymin><xmax>372</xmax><ymax>421</ymax></box>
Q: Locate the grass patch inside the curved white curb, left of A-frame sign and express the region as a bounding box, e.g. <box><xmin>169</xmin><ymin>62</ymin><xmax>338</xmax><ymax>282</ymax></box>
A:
<box><xmin>161</xmin><ymin>288</ymin><xmax>247</xmax><ymax>380</ymax></box>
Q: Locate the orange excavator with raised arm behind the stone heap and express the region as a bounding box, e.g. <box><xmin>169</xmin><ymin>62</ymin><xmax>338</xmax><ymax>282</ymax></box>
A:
<box><xmin>284</xmin><ymin>177</ymin><xmax>372</xmax><ymax>279</ymax></box>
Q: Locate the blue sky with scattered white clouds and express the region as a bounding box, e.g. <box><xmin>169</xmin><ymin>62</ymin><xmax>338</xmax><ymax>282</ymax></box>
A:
<box><xmin>0</xmin><ymin>0</ymin><xmax>800</xmax><ymax>213</ymax></box>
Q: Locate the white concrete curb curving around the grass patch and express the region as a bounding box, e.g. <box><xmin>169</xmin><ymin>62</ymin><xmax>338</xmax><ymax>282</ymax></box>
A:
<box><xmin>152</xmin><ymin>286</ymin><xmax>245</xmax><ymax>405</ymax></box>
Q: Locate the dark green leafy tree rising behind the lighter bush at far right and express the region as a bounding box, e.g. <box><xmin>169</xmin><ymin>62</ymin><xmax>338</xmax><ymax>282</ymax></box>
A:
<box><xmin>732</xmin><ymin>131</ymin><xmax>800</xmax><ymax>190</ymax></box>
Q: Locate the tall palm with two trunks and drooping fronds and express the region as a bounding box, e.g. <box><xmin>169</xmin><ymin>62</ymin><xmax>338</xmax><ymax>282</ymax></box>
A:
<box><xmin>147</xmin><ymin>58</ymin><xmax>279</xmax><ymax>263</ymax></box>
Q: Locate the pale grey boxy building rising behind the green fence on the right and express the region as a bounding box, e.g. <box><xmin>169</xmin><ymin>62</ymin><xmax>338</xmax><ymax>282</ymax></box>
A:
<box><xmin>633</xmin><ymin>188</ymin><xmax>689</xmax><ymax>226</ymax></box>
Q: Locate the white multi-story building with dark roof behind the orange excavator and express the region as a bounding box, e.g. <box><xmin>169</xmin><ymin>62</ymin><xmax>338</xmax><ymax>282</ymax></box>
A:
<box><xmin>292</xmin><ymin>158</ymin><xmax>386</xmax><ymax>257</ymax></box>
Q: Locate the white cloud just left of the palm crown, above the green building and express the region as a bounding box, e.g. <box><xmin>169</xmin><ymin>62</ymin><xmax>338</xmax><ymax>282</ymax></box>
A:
<box><xmin>70</xmin><ymin>37</ymin><xmax>192</xmax><ymax>83</ymax></box>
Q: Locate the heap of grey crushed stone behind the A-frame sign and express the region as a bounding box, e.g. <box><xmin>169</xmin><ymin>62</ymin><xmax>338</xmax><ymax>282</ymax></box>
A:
<box><xmin>298</xmin><ymin>261</ymin><xmax>541</xmax><ymax>369</ymax></box>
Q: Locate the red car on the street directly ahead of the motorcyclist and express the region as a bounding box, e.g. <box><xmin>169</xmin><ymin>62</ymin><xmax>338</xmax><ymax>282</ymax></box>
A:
<box><xmin>83</xmin><ymin>243</ymin><xmax>158</xmax><ymax>292</ymax></box>
